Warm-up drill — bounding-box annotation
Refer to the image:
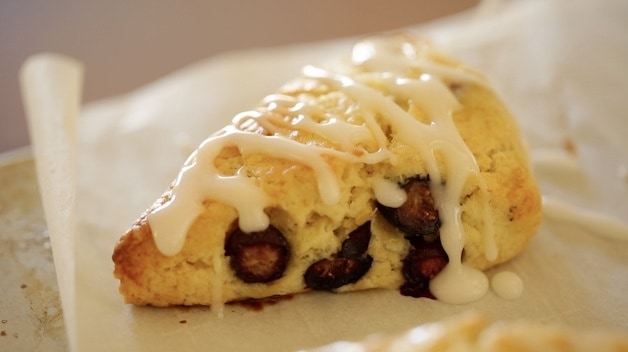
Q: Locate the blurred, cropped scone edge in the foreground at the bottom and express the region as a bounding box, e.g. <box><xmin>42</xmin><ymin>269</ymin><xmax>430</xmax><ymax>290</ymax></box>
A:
<box><xmin>301</xmin><ymin>312</ymin><xmax>628</xmax><ymax>352</ymax></box>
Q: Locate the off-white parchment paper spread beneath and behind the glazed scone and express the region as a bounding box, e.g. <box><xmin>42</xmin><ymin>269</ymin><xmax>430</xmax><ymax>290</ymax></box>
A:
<box><xmin>22</xmin><ymin>0</ymin><xmax>628</xmax><ymax>351</ymax></box>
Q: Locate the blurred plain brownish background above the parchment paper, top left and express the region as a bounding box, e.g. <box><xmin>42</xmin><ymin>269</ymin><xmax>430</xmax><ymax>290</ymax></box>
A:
<box><xmin>0</xmin><ymin>0</ymin><xmax>480</xmax><ymax>152</ymax></box>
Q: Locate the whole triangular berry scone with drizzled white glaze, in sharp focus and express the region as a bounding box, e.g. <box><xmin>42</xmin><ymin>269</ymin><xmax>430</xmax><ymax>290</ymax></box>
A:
<box><xmin>113</xmin><ymin>35</ymin><xmax>541</xmax><ymax>306</ymax></box>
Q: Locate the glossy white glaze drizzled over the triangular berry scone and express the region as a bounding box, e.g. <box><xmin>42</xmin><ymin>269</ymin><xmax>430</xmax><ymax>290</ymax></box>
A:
<box><xmin>148</xmin><ymin>38</ymin><xmax>497</xmax><ymax>303</ymax></box>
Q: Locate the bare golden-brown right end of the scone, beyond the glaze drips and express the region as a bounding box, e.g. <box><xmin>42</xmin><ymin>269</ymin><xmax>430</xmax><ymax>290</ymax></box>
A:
<box><xmin>454</xmin><ymin>87</ymin><xmax>542</xmax><ymax>269</ymax></box>
